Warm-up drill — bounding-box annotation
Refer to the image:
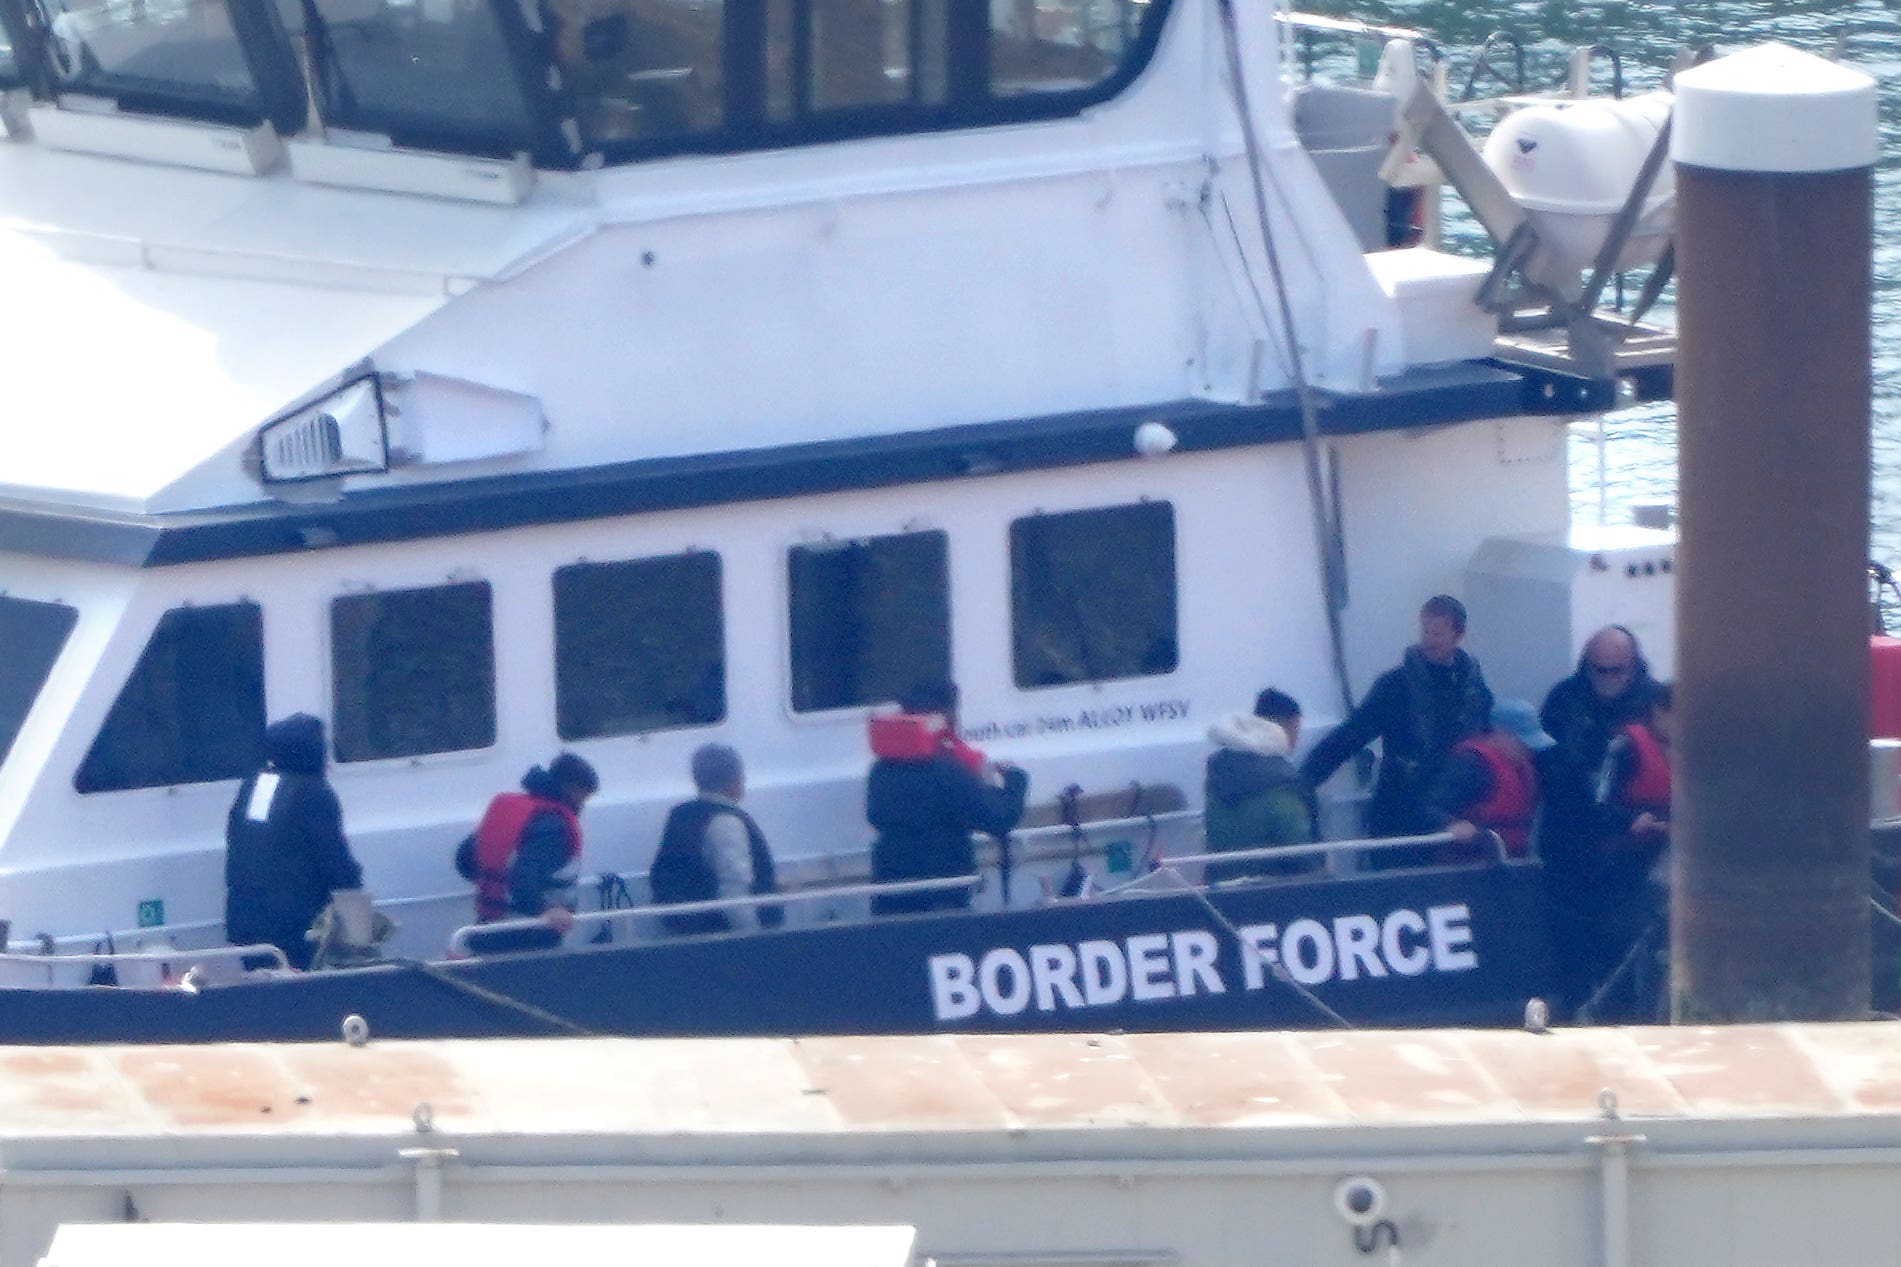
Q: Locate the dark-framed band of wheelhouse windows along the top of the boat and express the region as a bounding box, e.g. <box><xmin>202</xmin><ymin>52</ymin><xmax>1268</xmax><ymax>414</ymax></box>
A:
<box><xmin>0</xmin><ymin>0</ymin><xmax>1169</xmax><ymax>169</ymax></box>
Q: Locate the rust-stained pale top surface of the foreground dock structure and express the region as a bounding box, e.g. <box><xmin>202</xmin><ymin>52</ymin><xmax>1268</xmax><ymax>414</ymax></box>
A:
<box><xmin>0</xmin><ymin>1023</ymin><xmax>1901</xmax><ymax>1174</ymax></box>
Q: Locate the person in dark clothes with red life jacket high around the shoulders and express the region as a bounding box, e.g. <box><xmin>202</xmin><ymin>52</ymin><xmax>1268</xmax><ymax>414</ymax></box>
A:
<box><xmin>865</xmin><ymin>681</ymin><xmax>1030</xmax><ymax>915</ymax></box>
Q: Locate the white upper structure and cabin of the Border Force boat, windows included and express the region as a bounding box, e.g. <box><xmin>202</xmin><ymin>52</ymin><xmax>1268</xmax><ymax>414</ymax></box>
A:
<box><xmin>0</xmin><ymin>0</ymin><xmax>1695</xmax><ymax>1037</ymax></box>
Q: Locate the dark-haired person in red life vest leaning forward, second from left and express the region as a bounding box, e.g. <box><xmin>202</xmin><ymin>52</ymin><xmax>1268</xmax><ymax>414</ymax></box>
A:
<box><xmin>456</xmin><ymin>751</ymin><xmax>601</xmax><ymax>953</ymax></box>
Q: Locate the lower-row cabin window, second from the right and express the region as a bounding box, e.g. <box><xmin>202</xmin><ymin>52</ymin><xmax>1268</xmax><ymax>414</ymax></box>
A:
<box><xmin>787</xmin><ymin>533</ymin><xmax>951</xmax><ymax>713</ymax></box>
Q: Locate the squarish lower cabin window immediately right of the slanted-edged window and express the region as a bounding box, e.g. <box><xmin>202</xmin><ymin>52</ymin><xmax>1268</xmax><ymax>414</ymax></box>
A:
<box><xmin>331</xmin><ymin>580</ymin><xmax>494</xmax><ymax>761</ymax></box>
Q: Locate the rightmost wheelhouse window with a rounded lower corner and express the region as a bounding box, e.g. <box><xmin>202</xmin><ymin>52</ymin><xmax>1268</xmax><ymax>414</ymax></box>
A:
<box><xmin>990</xmin><ymin>0</ymin><xmax>1156</xmax><ymax>97</ymax></box>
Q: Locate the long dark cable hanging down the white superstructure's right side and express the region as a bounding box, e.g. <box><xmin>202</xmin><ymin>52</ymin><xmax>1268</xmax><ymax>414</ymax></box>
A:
<box><xmin>1217</xmin><ymin>0</ymin><xmax>1354</xmax><ymax>715</ymax></box>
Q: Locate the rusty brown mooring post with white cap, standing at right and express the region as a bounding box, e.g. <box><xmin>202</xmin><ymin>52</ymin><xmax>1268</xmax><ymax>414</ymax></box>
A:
<box><xmin>1671</xmin><ymin>44</ymin><xmax>1878</xmax><ymax>1023</ymax></box>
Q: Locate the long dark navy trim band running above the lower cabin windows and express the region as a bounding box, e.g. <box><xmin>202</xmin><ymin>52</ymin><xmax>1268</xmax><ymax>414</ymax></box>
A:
<box><xmin>0</xmin><ymin>363</ymin><xmax>1582</xmax><ymax>567</ymax></box>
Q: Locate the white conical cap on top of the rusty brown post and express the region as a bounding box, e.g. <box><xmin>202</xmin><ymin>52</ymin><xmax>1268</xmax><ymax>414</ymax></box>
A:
<box><xmin>1669</xmin><ymin>44</ymin><xmax>1880</xmax><ymax>173</ymax></box>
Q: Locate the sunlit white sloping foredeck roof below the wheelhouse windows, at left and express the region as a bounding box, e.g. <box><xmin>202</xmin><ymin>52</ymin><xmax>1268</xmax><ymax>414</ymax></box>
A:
<box><xmin>0</xmin><ymin>145</ymin><xmax>591</xmax><ymax>510</ymax></box>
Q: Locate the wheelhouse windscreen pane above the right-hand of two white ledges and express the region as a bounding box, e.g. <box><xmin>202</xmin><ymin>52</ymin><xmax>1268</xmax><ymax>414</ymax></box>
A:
<box><xmin>308</xmin><ymin>0</ymin><xmax>565</xmax><ymax>162</ymax></box>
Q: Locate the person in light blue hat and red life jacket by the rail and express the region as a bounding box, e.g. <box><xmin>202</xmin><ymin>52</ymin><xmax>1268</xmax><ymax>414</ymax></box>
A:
<box><xmin>1426</xmin><ymin>700</ymin><xmax>1557</xmax><ymax>864</ymax></box>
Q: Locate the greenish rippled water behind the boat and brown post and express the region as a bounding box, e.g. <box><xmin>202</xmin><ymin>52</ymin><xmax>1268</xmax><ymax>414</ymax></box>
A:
<box><xmin>1296</xmin><ymin>0</ymin><xmax>1901</xmax><ymax>563</ymax></box>
